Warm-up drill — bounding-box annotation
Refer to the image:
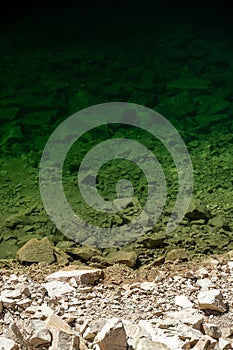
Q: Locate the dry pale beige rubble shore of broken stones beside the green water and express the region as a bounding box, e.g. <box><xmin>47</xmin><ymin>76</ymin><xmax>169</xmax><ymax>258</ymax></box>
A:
<box><xmin>0</xmin><ymin>254</ymin><xmax>233</xmax><ymax>350</ymax></box>
